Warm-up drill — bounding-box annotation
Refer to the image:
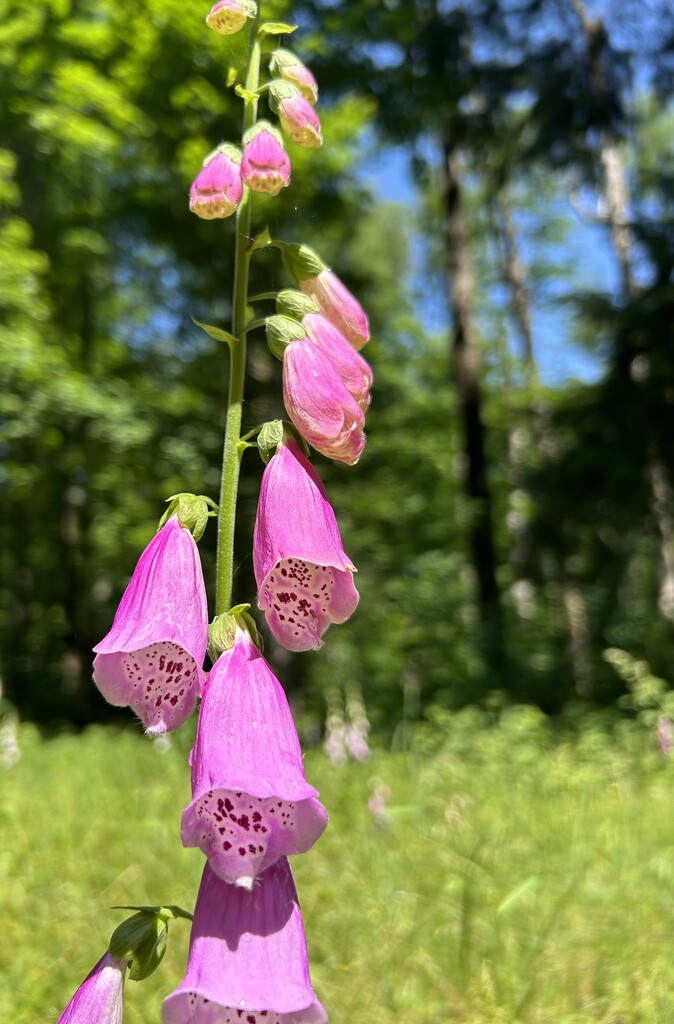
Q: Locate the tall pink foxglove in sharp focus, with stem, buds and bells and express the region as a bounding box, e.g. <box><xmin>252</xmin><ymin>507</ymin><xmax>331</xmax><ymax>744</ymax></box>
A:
<box><xmin>59</xmin><ymin>0</ymin><xmax>372</xmax><ymax>1024</ymax></box>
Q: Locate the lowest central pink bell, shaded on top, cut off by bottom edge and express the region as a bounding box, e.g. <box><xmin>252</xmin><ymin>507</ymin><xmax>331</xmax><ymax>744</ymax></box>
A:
<box><xmin>162</xmin><ymin>857</ymin><xmax>328</xmax><ymax>1024</ymax></box>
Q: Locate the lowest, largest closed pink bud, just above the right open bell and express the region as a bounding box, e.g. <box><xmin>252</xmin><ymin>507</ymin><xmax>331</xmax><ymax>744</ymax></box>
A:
<box><xmin>283</xmin><ymin>338</ymin><xmax>365</xmax><ymax>466</ymax></box>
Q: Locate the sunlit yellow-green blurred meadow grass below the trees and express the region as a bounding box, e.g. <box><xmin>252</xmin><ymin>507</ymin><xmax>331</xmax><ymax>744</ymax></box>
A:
<box><xmin>0</xmin><ymin>709</ymin><xmax>674</xmax><ymax>1024</ymax></box>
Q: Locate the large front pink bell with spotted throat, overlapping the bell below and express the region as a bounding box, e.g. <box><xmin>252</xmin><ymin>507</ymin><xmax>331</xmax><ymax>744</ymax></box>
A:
<box><xmin>180</xmin><ymin>627</ymin><xmax>328</xmax><ymax>888</ymax></box>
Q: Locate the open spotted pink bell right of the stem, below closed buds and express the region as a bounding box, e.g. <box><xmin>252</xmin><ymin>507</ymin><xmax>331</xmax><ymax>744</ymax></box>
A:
<box><xmin>253</xmin><ymin>440</ymin><xmax>359</xmax><ymax>650</ymax></box>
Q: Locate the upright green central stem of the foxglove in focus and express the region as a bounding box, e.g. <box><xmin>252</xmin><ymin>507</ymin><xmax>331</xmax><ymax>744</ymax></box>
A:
<box><xmin>215</xmin><ymin>14</ymin><xmax>260</xmax><ymax>615</ymax></box>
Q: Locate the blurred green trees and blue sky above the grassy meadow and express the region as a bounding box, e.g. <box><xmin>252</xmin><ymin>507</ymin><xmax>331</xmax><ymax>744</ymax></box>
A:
<box><xmin>0</xmin><ymin>0</ymin><xmax>674</xmax><ymax>749</ymax></box>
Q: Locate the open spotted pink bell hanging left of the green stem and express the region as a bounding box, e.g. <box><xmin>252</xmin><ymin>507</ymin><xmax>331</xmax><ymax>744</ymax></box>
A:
<box><xmin>93</xmin><ymin>516</ymin><xmax>208</xmax><ymax>735</ymax></box>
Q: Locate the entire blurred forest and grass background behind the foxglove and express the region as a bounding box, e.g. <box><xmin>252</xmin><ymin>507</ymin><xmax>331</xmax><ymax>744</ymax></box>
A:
<box><xmin>0</xmin><ymin>0</ymin><xmax>674</xmax><ymax>1024</ymax></box>
